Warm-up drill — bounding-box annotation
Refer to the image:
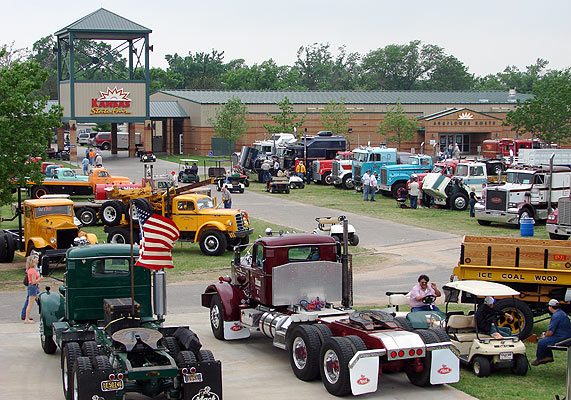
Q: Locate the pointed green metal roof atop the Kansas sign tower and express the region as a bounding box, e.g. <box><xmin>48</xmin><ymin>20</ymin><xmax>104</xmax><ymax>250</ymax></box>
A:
<box><xmin>55</xmin><ymin>8</ymin><xmax>152</xmax><ymax>39</ymax></box>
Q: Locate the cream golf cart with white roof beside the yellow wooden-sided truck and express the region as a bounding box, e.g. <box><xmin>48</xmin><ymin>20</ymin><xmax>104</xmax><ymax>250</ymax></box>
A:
<box><xmin>443</xmin><ymin>280</ymin><xmax>528</xmax><ymax>377</ymax></box>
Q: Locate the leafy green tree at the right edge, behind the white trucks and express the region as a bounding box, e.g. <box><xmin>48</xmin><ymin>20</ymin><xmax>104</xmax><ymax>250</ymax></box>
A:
<box><xmin>504</xmin><ymin>70</ymin><xmax>571</xmax><ymax>143</ymax></box>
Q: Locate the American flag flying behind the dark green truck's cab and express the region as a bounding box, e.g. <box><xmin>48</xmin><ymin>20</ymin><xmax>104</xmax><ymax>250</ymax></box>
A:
<box><xmin>134</xmin><ymin>203</ymin><xmax>180</xmax><ymax>269</ymax></box>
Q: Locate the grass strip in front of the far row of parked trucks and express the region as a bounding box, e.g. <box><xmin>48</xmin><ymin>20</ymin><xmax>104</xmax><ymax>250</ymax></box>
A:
<box><xmin>248</xmin><ymin>176</ymin><xmax>549</xmax><ymax>239</ymax></box>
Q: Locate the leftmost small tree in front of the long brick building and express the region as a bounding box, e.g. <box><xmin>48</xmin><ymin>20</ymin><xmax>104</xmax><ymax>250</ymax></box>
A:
<box><xmin>208</xmin><ymin>97</ymin><xmax>249</xmax><ymax>142</ymax></box>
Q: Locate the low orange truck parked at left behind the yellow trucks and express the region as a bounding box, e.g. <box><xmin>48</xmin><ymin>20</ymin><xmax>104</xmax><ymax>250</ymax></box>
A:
<box><xmin>29</xmin><ymin>168</ymin><xmax>131</xmax><ymax>199</ymax></box>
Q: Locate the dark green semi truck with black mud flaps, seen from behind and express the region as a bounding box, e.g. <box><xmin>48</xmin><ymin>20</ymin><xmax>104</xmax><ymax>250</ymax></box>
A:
<box><xmin>37</xmin><ymin>244</ymin><xmax>222</xmax><ymax>400</ymax></box>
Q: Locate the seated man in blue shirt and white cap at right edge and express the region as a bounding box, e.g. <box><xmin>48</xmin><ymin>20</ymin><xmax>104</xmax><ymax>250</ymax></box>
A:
<box><xmin>531</xmin><ymin>299</ymin><xmax>571</xmax><ymax>366</ymax></box>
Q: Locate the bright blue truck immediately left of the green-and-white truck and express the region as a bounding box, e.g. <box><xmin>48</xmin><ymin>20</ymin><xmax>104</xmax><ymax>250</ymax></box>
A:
<box><xmin>379</xmin><ymin>154</ymin><xmax>432</xmax><ymax>197</ymax></box>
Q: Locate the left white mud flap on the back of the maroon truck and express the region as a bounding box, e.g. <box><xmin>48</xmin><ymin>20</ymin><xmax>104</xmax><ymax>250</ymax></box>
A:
<box><xmin>349</xmin><ymin>350</ymin><xmax>380</xmax><ymax>396</ymax></box>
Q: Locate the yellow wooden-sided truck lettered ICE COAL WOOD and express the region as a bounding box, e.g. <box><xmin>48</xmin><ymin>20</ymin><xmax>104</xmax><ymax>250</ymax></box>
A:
<box><xmin>450</xmin><ymin>236</ymin><xmax>571</xmax><ymax>338</ymax></box>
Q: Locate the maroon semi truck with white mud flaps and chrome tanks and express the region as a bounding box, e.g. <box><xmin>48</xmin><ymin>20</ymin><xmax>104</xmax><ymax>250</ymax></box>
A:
<box><xmin>202</xmin><ymin>234</ymin><xmax>459</xmax><ymax>396</ymax></box>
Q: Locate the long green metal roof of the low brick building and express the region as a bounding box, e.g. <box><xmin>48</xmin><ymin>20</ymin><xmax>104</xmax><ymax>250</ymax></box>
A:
<box><xmin>154</xmin><ymin>90</ymin><xmax>533</xmax><ymax>104</ymax></box>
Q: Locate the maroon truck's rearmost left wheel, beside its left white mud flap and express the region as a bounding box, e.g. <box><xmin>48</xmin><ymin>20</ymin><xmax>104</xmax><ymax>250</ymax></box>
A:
<box><xmin>319</xmin><ymin>337</ymin><xmax>355</xmax><ymax>396</ymax></box>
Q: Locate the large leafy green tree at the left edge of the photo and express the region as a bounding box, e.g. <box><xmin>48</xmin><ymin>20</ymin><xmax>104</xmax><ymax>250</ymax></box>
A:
<box><xmin>0</xmin><ymin>54</ymin><xmax>62</xmax><ymax>204</ymax></box>
